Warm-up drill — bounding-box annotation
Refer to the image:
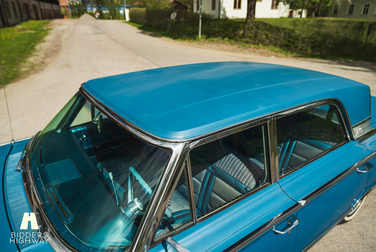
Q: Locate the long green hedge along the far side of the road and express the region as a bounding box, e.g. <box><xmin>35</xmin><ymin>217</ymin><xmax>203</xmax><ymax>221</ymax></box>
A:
<box><xmin>130</xmin><ymin>9</ymin><xmax>376</xmax><ymax>59</ymax></box>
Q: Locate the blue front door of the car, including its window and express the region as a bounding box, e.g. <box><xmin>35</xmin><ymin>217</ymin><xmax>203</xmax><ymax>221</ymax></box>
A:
<box><xmin>150</xmin><ymin>123</ymin><xmax>301</xmax><ymax>251</ymax></box>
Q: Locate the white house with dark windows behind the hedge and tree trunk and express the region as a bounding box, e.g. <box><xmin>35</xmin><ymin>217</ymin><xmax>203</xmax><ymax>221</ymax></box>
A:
<box><xmin>193</xmin><ymin>0</ymin><xmax>307</xmax><ymax>18</ymax></box>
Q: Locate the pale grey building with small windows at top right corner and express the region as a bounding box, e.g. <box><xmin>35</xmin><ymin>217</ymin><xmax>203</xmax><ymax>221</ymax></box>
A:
<box><xmin>328</xmin><ymin>0</ymin><xmax>376</xmax><ymax>20</ymax></box>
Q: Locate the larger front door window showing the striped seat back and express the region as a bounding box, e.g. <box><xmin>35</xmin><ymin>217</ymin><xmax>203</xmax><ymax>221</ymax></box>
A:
<box><xmin>190</xmin><ymin>125</ymin><xmax>269</xmax><ymax>218</ymax></box>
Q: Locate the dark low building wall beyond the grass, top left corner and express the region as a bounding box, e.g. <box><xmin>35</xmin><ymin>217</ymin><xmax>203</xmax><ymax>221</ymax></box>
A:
<box><xmin>0</xmin><ymin>0</ymin><xmax>61</xmax><ymax>27</ymax></box>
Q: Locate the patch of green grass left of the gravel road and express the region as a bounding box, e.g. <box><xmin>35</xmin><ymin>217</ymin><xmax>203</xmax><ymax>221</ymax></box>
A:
<box><xmin>0</xmin><ymin>21</ymin><xmax>50</xmax><ymax>85</ymax></box>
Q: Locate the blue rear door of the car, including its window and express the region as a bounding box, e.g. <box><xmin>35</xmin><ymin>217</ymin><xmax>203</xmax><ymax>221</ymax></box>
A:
<box><xmin>275</xmin><ymin>103</ymin><xmax>372</xmax><ymax>251</ymax></box>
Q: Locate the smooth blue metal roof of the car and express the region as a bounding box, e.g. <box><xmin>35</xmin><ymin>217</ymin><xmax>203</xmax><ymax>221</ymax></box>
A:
<box><xmin>82</xmin><ymin>62</ymin><xmax>370</xmax><ymax>141</ymax></box>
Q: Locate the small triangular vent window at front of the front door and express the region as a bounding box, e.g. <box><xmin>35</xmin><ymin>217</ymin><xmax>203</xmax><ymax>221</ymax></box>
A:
<box><xmin>154</xmin><ymin>168</ymin><xmax>192</xmax><ymax>239</ymax></box>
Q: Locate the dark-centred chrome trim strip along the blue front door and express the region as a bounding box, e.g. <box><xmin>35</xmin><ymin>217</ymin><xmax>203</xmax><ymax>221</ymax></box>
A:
<box><xmin>223</xmin><ymin>199</ymin><xmax>302</xmax><ymax>252</ymax></box>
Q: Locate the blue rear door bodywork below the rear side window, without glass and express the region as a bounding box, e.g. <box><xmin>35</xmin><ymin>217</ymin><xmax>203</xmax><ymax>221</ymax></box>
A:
<box><xmin>279</xmin><ymin>141</ymin><xmax>371</xmax><ymax>251</ymax></box>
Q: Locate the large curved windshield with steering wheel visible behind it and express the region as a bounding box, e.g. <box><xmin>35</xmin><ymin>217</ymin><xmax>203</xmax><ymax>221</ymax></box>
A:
<box><xmin>30</xmin><ymin>93</ymin><xmax>170</xmax><ymax>251</ymax></box>
